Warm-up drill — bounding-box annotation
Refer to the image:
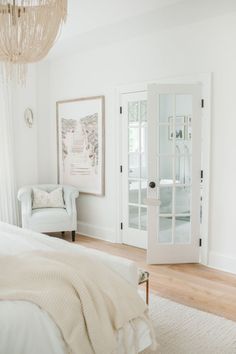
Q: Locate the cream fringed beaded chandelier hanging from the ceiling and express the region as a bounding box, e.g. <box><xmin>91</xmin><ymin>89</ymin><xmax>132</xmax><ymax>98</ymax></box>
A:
<box><xmin>0</xmin><ymin>0</ymin><xmax>67</xmax><ymax>83</ymax></box>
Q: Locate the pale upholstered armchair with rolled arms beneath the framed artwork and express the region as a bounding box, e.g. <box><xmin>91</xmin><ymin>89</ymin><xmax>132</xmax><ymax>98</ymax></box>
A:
<box><xmin>18</xmin><ymin>184</ymin><xmax>79</xmax><ymax>242</ymax></box>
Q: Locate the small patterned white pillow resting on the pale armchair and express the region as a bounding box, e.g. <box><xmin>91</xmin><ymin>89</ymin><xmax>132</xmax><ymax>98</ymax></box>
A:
<box><xmin>32</xmin><ymin>187</ymin><xmax>65</xmax><ymax>209</ymax></box>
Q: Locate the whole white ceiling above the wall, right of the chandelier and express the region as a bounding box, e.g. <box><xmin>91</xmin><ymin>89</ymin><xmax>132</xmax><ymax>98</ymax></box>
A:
<box><xmin>49</xmin><ymin>0</ymin><xmax>236</xmax><ymax>60</ymax></box>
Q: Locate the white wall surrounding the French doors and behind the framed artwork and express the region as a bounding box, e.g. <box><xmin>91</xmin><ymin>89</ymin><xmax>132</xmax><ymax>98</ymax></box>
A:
<box><xmin>38</xmin><ymin>11</ymin><xmax>236</xmax><ymax>272</ymax></box>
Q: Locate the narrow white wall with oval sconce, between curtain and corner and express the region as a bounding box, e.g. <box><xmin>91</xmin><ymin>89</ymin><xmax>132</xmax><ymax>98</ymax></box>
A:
<box><xmin>13</xmin><ymin>65</ymin><xmax>38</xmax><ymax>188</ymax></box>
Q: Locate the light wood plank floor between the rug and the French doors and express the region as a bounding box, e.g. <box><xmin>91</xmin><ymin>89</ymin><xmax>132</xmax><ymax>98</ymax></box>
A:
<box><xmin>62</xmin><ymin>235</ymin><xmax>236</xmax><ymax>321</ymax></box>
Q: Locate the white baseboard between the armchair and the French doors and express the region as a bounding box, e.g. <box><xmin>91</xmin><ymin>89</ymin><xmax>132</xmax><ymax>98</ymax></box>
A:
<box><xmin>77</xmin><ymin>221</ymin><xmax>116</xmax><ymax>243</ymax></box>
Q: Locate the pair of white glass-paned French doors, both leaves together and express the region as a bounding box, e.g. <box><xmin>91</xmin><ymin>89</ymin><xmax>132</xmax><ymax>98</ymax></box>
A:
<box><xmin>121</xmin><ymin>84</ymin><xmax>201</xmax><ymax>264</ymax></box>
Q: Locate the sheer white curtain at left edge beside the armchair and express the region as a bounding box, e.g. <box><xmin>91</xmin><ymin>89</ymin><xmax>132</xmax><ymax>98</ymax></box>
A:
<box><xmin>0</xmin><ymin>82</ymin><xmax>18</xmax><ymax>224</ymax></box>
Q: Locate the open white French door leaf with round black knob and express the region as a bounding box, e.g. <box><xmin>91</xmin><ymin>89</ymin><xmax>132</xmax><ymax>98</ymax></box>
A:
<box><xmin>146</xmin><ymin>84</ymin><xmax>201</xmax><ymax>264</ymax></box>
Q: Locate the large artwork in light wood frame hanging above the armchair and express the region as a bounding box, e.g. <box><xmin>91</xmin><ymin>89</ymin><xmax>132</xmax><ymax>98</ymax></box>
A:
<box><xmin>56</xmin><ymin>96</ymin><xmax>105</xmax><ymax>195</ymax></box>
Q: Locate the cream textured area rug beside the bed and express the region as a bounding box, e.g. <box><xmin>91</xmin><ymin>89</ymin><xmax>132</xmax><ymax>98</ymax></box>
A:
<box><xmin>142</xmin><ymin>294</ymin><xmax>236</xmax><ymax>354</ymax></box>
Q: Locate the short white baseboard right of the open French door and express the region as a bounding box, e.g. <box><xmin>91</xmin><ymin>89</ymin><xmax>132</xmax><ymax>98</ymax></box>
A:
<box><xmin>208</xmin><ymin>252</ymin><xmax>236</xmax><ymax>274</ymax></box>
